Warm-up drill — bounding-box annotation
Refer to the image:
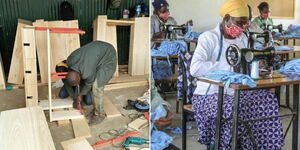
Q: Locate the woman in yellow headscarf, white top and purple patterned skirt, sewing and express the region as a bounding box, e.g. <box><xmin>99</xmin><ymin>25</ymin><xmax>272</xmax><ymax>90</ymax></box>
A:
<box><xmin>190</xmin><ymin>0</ymin><xmax>284</xmax><ymax>150</ymax></box>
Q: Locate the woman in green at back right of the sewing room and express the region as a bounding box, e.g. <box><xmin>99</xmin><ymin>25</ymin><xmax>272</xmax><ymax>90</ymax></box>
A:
<box><xmin>253</xmin><ymin>2</ymin><xmax>273</xmax><ymax>30</ymax></box>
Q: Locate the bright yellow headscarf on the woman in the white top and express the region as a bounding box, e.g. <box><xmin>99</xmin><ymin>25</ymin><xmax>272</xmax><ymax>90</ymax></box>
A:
<box><xmin>220</xmin><ymin>0</ymin><xmax>249</xmax><ymax>17</ymax></box>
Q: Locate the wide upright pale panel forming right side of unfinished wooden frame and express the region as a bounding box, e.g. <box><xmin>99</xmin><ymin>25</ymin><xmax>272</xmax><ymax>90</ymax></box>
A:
<box><xmin>128</xmin><ymin>17</ymin><xmax>150</xmax><ymax>75</ymax></box>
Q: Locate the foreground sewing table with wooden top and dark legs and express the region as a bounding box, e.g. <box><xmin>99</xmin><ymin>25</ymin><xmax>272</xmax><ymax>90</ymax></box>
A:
<box><xmin>198</xmin><ymin>76</ymin><xmax>300</xmax><ymax>150</ymax></box>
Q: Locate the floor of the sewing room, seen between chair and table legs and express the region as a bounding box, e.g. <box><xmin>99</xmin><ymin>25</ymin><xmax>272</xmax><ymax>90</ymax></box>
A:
<box><xmin>162</xmin><ymin>91</ymin><xmax>300</xmax><ymax>150</ymax></box>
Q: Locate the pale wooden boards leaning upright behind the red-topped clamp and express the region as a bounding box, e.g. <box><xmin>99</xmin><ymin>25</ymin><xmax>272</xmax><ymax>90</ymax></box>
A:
<box><xmin>33</xmin><ymin>20</ymin><xmax>80</xmax><ymax>83</ymax></box>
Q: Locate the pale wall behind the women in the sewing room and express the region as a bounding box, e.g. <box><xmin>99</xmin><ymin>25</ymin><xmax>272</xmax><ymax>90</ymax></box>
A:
<box><xmin>168</xmin><ymin>0</ymin><xmax>300</xmax><ymax>32</ymax></box>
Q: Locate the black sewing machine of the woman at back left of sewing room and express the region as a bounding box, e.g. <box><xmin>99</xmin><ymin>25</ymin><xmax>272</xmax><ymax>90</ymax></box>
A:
<box><xmin>160</xmin><ymin>24</ymin><xmax>187</xmax><ymax>40</ymax></box>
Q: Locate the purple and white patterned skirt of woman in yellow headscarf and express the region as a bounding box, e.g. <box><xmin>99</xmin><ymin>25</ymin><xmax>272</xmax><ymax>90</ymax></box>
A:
<box><xmin>192</xmin><ymin>89</ymin><xmax>284</xmax><ymax>150</ymax></box>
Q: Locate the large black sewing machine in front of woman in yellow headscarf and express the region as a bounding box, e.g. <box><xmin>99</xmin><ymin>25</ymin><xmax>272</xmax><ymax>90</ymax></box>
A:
<box><xmin>225</xmin><ymin>44</ymin><xmax>281</xmax><ymax>75</ymax></box>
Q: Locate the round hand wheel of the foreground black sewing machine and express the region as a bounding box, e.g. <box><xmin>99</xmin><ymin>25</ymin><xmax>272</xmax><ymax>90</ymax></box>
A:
<box><xmin>225</xmin><ymin>44</ymin><xmax>242</xmax><ymax>67</ymax></box>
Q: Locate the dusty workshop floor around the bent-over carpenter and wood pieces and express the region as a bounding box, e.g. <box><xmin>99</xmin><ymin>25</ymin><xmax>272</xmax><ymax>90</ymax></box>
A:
<box><xmin>0</xmin><ymin>86</ymin><xmax>149</xmax><ymax>150</ymax></box>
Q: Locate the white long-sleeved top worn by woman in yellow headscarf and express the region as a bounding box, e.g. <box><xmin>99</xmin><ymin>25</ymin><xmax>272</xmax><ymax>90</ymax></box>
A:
<box><xmin>190</xmin><ymin>24</ymin><xmax>248</xmax><ymax>95</ymax></box>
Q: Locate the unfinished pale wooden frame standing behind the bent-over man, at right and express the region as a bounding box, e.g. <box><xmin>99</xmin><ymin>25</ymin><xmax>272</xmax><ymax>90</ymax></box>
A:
<box><xmin>93</xmin><ymin>16</ymin><xmax>150</xmax><ymax>76</ymax></box>
